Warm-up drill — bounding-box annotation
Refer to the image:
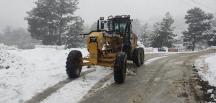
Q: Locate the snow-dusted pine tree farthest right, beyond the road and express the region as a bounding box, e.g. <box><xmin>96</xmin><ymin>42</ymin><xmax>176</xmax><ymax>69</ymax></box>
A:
<box><xmin>183</xmin><ymin>7</ymin><xmax>213</xmax><ymax>51</ymax></box>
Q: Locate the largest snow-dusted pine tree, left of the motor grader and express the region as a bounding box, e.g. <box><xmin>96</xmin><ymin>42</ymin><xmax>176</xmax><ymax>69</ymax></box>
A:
<box><xmin>26</xmin><ymin>0</ymin><xmax>78</xmax><ymax>45</ymax></box>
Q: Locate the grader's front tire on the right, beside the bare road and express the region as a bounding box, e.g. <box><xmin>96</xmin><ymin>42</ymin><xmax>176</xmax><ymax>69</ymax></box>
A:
<box><xmin>114</xmin><ymin>52</ymin><xmax>127</xmax><ymax>84</ymax></box>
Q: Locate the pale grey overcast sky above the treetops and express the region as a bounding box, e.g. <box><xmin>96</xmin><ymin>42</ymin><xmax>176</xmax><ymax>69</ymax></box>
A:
<box><xmin>0</xmin><ymin>0</ymin><xmax>216</xmax><ymax>30</ymax></box>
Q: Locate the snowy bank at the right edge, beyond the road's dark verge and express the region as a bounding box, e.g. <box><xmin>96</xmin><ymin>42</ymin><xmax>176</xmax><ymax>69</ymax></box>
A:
<box><xmin>195</xmin><ymin>54</ymin><xmax>216</xmax><ymax>86</ymax></box>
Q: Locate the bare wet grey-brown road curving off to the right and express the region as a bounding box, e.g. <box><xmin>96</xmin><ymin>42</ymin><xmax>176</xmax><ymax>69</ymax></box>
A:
<box><xmin>80</xmin><ymin>50</ymin><xmax>215</xmax><ymax>103</ymax></box>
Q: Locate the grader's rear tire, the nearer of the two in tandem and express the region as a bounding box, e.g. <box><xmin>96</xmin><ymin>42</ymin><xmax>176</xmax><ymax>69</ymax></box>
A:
<box><xmin>133</xmin><ymin>48</ymin><xmax>141</xmax><ymax>67</ymax></box>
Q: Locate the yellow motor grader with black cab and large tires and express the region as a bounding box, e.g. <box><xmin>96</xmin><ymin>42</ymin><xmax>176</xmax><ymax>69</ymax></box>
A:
<box><xmin>66</xmin><ymin>15</ymin><xmax>144</xmax><ymax>83</ymax></box>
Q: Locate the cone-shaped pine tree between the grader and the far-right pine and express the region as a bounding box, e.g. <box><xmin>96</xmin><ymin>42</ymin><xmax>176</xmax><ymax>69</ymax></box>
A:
<box><xmin>151</xmin><ymin>12</ymin><xmax>176</xmax><ymax>48</ymax></box>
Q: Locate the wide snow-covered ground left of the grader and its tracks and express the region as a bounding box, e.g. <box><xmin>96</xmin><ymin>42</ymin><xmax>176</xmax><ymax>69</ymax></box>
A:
<box><xmin>0</xmin><ymin>48</ymin><xmax>86</xmax><ymax>103</ymax></box>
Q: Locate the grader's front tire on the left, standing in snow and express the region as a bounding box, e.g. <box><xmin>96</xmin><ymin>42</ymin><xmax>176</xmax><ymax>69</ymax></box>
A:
<box><xmin>66</xmin><ymin>50</ymin><xmax>83</xmax><ymax>78</ymax></box>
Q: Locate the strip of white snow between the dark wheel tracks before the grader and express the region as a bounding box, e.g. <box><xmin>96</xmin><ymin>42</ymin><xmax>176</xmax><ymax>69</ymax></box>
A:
<box><xmin>42</xmin><ymin>67</ymin><xmax>112</xmax><ymax>103</ymax></box>
